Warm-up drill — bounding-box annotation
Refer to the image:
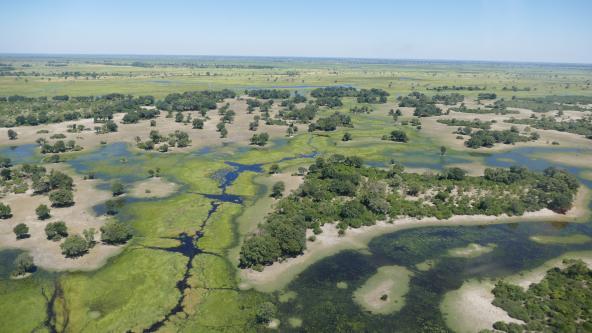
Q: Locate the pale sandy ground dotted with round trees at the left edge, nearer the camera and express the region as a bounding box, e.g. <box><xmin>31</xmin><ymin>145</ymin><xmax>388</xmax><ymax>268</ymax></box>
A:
<box><xmin>0</xmin><ymin>165</ymin><xmax>122</xmax><ymax>271</ymax></box>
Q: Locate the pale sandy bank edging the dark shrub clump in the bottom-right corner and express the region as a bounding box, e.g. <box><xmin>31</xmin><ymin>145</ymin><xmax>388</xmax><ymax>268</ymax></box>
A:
<box><xmin>441</xmin><ymin>251</ymin><xmax>592</xmax><ymax>333</ymax></box>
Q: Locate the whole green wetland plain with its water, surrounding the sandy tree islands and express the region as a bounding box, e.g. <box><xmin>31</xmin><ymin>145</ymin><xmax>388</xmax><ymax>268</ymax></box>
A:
<box><xmin>0</xmin><ymin>56</ymin><xmax>592</xmax><ymax>332</ymax></box>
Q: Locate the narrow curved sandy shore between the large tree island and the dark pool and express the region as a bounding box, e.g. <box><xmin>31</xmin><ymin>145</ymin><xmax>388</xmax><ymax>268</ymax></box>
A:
<box><xmin>240</xmin><ymin>187</ymin><xmax>589</xmax><ymax>292</ymax></box>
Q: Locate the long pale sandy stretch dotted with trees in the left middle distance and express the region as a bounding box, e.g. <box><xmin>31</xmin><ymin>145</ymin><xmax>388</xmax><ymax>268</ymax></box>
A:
<box><xmin>0</xmin><ymin>99</ymin><xmax>294</xmax><ymax>151</ymax></box>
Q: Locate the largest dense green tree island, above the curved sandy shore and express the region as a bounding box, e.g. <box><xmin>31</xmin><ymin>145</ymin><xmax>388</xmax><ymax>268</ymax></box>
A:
<box><xmin>240</xmin><ymin>155</ymin><xmax>579</xmax><ymax>270</ymax></box>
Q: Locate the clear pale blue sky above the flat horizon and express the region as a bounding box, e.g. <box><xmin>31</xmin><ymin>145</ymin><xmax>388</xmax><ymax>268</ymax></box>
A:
<box><xmin>0</xmin><ymin>0</ymin><xmax>592</xmax><ymax>64</ymax></box>
